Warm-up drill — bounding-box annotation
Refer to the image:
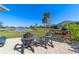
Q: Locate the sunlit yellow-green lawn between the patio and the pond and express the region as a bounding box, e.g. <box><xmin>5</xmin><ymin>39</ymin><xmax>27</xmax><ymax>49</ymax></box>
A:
<box><xmin>0</xmin><ymin>28</ymin><xmax>49</xmax><ymax>38</ymax></box>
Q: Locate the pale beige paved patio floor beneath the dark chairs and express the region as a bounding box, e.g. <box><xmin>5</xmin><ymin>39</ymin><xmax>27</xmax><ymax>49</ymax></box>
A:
<box><xmin>0</xmin><ymin>38</ymin><xmax>76</xmax><ymax>54</ymax></box>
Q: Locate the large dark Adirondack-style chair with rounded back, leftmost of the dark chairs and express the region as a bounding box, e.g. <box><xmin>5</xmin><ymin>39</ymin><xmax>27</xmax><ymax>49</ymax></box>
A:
<box><xmin>14</xmin><ymin>32</ymin><xmax>34</xmax><ymax>54</ymax></box>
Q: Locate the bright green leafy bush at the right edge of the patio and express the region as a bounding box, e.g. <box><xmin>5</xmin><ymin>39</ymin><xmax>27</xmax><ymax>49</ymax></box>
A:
<box><xmin>64</xmin><ymin>24</ymin><xmax>79</xmax><ymax>41</ymax></box>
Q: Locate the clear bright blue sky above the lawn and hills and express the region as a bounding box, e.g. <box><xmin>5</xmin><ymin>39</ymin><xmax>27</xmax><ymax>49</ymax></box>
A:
<box><xmin>0</xmin><ymin>4</ymin><xmax>79</xmax><ymax>26</ymax></box>
